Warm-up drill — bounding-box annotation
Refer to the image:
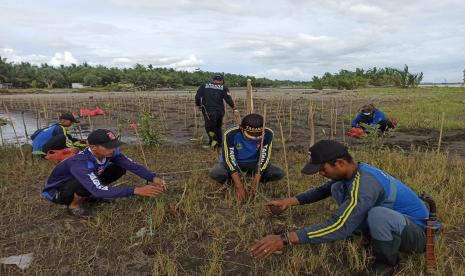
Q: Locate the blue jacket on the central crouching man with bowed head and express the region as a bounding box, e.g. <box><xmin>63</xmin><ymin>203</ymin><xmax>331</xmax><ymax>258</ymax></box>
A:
<box><xmin>220</xmin><ymin>127</ymin><xmax>273</xmax><ymax>174</ymax></box>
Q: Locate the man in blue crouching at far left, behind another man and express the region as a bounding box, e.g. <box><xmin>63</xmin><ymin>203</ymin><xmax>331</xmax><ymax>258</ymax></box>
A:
<box><xmin>31</xmin><ymin>113</ymin><xmax>85</xmax><ymax>155</ymax></box>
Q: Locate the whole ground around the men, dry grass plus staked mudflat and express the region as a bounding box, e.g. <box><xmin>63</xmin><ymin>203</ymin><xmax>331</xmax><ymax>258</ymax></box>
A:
<box><xmin>0</xmin><ymin>90</ymin><xmax>465</xmax><ymax>275</ymax></box>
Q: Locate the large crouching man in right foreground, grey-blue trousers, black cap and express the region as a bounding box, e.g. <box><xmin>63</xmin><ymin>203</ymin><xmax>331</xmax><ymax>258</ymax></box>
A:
<box><xmin>251</xmin><ymin>140</ymin><xmax>429</xmax><ymax>275</ymax></box>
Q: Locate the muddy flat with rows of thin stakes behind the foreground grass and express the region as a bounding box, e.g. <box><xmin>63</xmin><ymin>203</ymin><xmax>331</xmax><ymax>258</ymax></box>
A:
<box><xmin>0</xmin><ymin>89</ymin><xmax>465</xmax><ymax>156</ymax></box>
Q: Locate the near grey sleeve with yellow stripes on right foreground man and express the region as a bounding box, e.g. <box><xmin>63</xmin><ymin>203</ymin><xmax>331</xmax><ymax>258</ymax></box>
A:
<box><xmin>297</xmin><ymin>172</ymin><xmax>382</xmax><ymax>243</ymax></box>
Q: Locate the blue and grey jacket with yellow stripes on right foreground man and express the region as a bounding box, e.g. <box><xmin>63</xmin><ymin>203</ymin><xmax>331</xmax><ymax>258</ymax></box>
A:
<box><xmin>296</xmin><ymin>163</ymin><xmax>429</xmax><ymax>243</ymax></box>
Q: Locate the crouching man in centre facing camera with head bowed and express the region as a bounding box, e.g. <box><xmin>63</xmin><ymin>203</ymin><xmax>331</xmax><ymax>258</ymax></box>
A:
<box><xmin>210</xmin><ymin>113</ymin><xmax>285</xmax><ymax>202</ymax></box>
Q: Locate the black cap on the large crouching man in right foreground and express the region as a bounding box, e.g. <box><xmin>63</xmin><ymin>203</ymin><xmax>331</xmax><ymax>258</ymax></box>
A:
<box><xmin>302</xmin><ymin>140</ymin><xmax>348</xmax><ymax>174</ymax></box>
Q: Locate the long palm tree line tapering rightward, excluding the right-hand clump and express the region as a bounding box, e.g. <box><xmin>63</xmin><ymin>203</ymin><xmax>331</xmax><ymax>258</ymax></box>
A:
<box><xmin>0</xmin><ymin>57</ymin><xmax>310</xmax><ymax>90</ymax></box>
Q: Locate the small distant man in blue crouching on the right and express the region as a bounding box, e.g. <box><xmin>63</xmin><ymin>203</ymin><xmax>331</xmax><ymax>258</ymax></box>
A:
<box><xmin>352</xmin><ymin>104</ymin><xmax>397</xmax><ymax>132</ymax></box>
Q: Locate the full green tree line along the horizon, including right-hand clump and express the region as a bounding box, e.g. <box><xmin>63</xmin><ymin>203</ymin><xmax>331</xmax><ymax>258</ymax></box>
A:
<box><xmin>0</xmin><ymin>56</ymin><xmax>423</xmax><ymax>91</ymax></box>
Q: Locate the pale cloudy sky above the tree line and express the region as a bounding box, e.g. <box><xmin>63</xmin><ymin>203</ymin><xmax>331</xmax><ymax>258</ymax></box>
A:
<box><xmin>0</xmin><ymin>0</ymin><xmax>465</xmax><ymax>82</ymax></box>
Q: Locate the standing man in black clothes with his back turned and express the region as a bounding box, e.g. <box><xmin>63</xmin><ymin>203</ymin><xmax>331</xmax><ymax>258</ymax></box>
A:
<box><xmin>195</xmin><ymin>74</ymin><xmax>239</xmax><ymax>148</ymax></box>
